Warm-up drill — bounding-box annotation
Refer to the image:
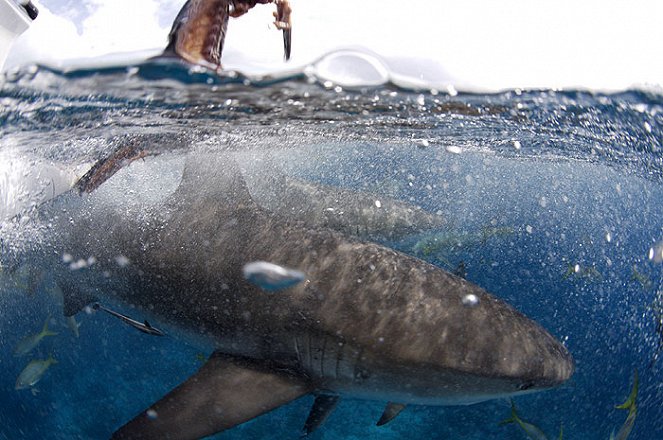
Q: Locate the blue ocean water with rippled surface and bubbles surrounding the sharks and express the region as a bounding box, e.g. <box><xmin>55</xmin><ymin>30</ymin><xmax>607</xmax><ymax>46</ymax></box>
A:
<box><xmin>0</xmin><ymin>59</ymin><xmax>663</xmax><ymax>440</ymax></box>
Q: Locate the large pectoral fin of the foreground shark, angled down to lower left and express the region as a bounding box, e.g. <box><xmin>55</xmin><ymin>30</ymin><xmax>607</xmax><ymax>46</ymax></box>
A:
<box><xmin>112</xmin><ymin>352</ymin><xmax>312</xmax><ymax>440</ymax></box>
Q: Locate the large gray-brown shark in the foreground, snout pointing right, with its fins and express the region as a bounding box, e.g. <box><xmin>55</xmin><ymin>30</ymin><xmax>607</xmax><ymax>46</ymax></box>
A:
<box><xmin>7</xmin><ymin>151</ymin><xmax>574</xmax><ymax>439</ymax></box>
